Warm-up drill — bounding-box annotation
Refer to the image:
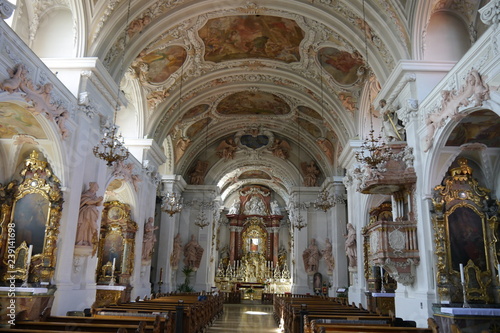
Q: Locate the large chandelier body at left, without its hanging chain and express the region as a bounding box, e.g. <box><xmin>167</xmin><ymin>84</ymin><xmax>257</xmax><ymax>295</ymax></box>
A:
<box><xmin>93</xmin><ymin>124</ymin><xmax>130</xmax><ymax>166</ymax></box>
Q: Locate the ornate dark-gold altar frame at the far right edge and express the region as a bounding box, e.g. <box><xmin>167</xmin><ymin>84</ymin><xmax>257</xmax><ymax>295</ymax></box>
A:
<box><xmin>432</xmin><ymin>158</ymin><xmax>498</xmax><ymax>303</ymax></box>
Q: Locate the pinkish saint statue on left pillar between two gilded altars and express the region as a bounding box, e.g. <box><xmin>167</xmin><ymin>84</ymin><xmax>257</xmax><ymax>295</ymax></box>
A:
<box><xmin>75</xmin><ymin>182</ymin><xmax>103</xmax><ymax>246</ymax></box>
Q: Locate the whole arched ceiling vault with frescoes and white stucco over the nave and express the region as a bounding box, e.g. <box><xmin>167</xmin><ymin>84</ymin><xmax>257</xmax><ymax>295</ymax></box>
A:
<box><xmin>89</xmin><ymin>0</ymin><xmax>412</xmax><ymax>195</ymax></box>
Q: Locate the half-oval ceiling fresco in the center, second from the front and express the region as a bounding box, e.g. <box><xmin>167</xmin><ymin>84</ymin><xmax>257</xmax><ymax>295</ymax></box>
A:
<box><xmin>217</xmin><ymin>91</ymin><xmax>290</xmax><ymax>116</ymax></box>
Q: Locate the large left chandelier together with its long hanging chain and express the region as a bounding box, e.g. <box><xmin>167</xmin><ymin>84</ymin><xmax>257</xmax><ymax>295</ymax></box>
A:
<box><xmin>93</xmin><ymin>0</ymin><xmax>130</xmax><ymax>166</ymax></box>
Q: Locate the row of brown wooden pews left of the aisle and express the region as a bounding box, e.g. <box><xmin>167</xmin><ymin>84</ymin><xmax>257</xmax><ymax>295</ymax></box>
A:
<box><xmin>0</xmin><ymin>293</ymin><xmax>223</xmax><ymax>333</ymax></box>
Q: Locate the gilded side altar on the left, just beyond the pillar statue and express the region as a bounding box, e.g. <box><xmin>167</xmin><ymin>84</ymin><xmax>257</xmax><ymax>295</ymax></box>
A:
<box><xmin>96</xmin><ymin>201</ymin><xmax>137</xmax><ymax>285</ymax></box>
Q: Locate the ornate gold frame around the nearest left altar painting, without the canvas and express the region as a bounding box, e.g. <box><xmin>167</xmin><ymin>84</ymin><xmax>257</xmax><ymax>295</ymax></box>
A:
<box><xmin>0</xmin><ymin>150</ymin><xmax>64</xmax><ymax>284</ymax></box>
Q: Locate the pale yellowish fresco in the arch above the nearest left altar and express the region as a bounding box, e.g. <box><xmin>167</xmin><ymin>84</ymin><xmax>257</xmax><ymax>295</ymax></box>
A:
<box><xmin>0</xmin><ymin>103</ymin><xmax>47</xmax><ymax>139</ymax></box>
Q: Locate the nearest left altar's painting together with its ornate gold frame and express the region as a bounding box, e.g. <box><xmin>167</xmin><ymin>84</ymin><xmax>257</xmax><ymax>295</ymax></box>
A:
<box><xmin>1</xmin><ymin>150</ymin><xmax>64</xmax><ymax>284</ymax></box>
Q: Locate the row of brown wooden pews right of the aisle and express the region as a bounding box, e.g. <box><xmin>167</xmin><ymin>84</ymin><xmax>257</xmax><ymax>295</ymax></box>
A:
<box><xmin>273</xmin><ymin>294</ymin><xmax>438</xmax><ymax>333</ymax></box>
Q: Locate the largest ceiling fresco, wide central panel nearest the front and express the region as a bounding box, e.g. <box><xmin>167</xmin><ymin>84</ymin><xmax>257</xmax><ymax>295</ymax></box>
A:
<box><xmin>198</xmin><ymin>15</ymin><xmax>304</xmax><ymax>63</ymax></box>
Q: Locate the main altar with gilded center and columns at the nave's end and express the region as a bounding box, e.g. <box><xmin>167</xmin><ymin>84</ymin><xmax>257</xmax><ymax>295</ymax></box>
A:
<box><xmin>215</xmin><ymin>186</ymin><xmax>291</xmax><ymax>299</ymax></box>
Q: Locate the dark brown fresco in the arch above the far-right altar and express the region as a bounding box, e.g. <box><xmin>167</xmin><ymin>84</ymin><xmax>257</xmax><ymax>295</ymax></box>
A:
<box><xmin>446</xmin><ymin>110</ymin><xmax>500</xmax><ymax>147</ymax></box>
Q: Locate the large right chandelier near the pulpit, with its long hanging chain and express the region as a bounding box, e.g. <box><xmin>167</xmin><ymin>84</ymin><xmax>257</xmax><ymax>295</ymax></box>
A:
<box><xmin>356</xmin><ymin>0</ymin><xmax>392</xmax><ymax>169</ymax></box>
